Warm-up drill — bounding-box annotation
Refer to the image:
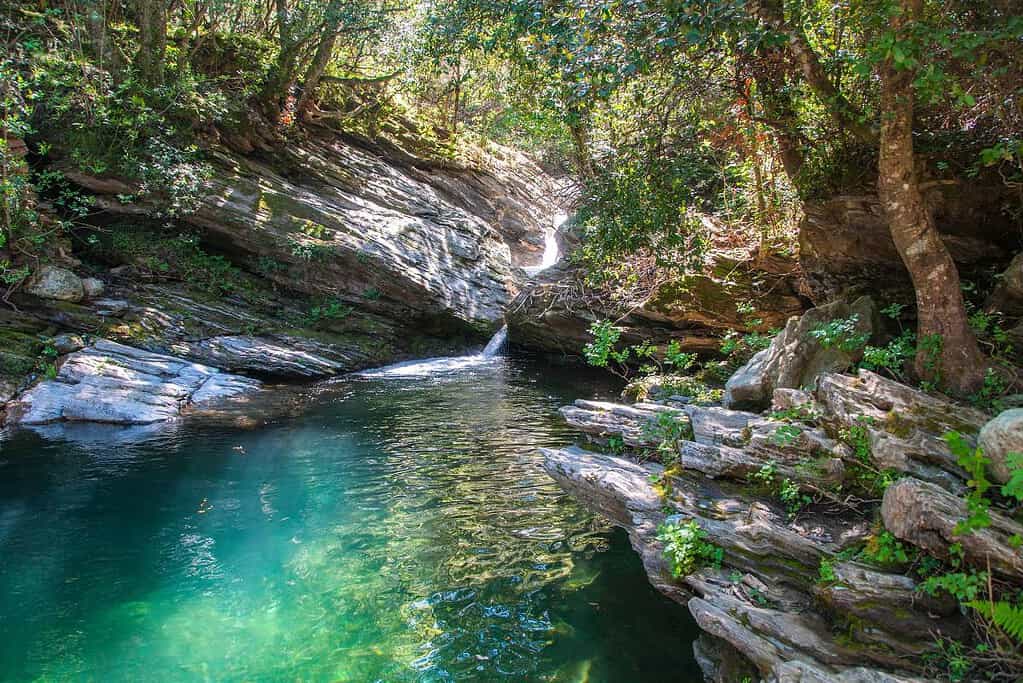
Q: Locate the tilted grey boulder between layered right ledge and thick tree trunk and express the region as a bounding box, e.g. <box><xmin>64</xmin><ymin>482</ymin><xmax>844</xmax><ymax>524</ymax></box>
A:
<box><xmin>724</xmin><ymin>297</ymin><xmax>879</xmax><ymax>409</ymax></box>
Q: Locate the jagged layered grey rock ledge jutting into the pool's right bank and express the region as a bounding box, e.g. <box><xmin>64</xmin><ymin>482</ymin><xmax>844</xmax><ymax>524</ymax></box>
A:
<box><xmin>542</xmin><ymin>371</ymin><xmax>1002</xmax><ymax>683</ymax></box>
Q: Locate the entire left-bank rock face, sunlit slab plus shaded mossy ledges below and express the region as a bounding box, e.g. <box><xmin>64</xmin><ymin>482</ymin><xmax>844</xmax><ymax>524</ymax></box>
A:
<box><xmin>0</xmin><ymin>127</ymin><xmax>557</xmax><ymax>421</ymax></box>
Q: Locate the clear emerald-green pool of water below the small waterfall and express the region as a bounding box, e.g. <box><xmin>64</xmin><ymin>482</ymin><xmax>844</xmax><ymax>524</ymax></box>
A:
<box><xmin>0</xmin><ymin>359</ymin><xmax>700</xmax><ymax>682</ymax></box>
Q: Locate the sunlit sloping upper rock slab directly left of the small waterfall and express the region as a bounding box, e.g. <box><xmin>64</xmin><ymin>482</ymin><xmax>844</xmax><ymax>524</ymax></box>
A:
<box><xmin>66</xmin><ymin>133</ymin><xmax>557</xmax><ymax>336</ymax></box>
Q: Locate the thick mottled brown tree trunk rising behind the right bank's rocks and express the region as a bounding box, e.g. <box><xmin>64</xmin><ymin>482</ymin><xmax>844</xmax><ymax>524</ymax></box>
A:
<box><xmin>878</xmin><ymin>0</ymin><xmax>984</xmax><ymax>394</ymax></box>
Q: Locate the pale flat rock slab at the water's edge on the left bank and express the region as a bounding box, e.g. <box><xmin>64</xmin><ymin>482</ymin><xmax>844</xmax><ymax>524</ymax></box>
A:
<box><xmin>7</xmin><ymin>339</ymin><xmax>262</xmax><ymax>424</ymax></box>
